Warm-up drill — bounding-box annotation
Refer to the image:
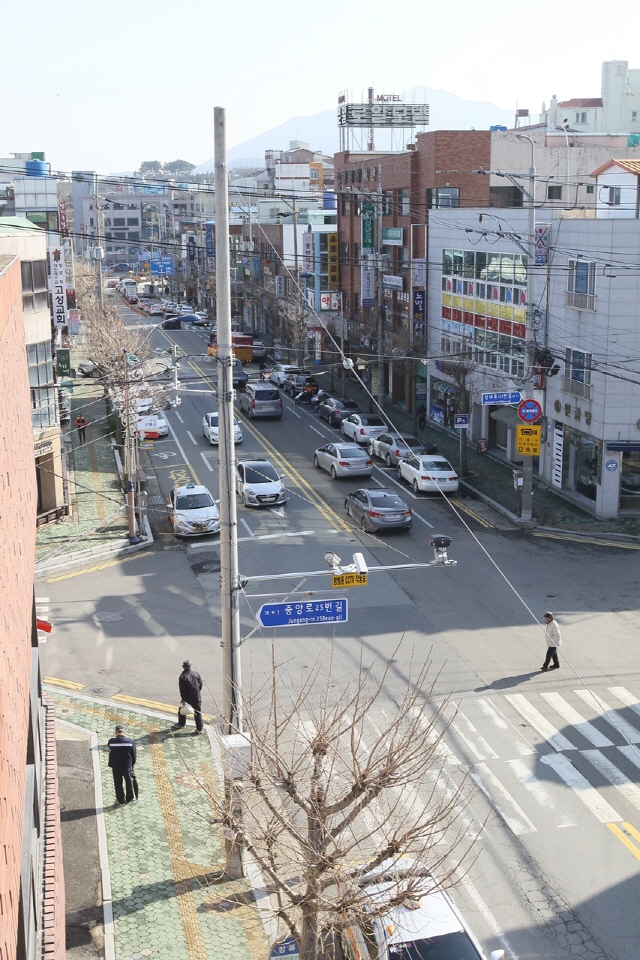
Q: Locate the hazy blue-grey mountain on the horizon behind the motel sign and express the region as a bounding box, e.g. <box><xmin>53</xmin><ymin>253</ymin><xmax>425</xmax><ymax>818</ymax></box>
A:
<box><xmin>194</xmin><ymin>87</ymin><xmax>514</xmax><ymax>173</ymax></box>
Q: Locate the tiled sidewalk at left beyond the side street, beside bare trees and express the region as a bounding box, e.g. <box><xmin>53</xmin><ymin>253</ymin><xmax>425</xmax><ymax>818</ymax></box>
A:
<box><xmin>36</xmin><ymin>358</ymin><xmax>128</xmax><ymax>563</ymax></box>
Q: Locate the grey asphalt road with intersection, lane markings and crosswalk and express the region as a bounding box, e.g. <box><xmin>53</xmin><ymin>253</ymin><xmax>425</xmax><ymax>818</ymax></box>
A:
<box><xmin>36</xmin><ymin>312</ymin><xmax>640</xmax><ymax>960</ymax></box>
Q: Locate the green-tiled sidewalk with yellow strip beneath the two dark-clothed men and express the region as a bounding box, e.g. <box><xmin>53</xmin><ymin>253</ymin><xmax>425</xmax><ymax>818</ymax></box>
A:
<box><xmin>47</xmin><ymin>688</ymin><xmax>268</xmax><ymax>960</ymax></box>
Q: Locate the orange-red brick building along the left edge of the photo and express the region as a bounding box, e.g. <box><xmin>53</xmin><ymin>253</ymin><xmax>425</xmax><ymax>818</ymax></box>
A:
<box><xmin>0</xmin><ymin>253</ymin><xmax>65</xmax><ymax>960</ymax></box>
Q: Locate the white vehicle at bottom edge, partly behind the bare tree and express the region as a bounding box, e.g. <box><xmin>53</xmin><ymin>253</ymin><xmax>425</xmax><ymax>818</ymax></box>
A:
<box><xmin>342</xmin><ymin>859</ymin><xmax>504</xmax><ymax>960</ymax></box>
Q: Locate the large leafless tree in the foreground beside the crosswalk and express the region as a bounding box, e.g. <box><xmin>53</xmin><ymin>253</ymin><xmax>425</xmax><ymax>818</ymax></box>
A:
<box><xmin>212</xmin><ymin>662</ymin><xmax>475</xmax><ymax>960</ymax></box>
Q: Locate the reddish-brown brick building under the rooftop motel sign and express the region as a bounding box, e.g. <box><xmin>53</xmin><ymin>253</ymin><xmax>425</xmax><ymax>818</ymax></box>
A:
<box><xmin>335</xmin><ymin>130</ymin><xmax>491</xmax><ymax>410</ymax></box>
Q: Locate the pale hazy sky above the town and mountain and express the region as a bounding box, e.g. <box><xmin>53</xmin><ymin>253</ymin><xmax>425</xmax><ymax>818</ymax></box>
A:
<box><xmin>0</xmin><ymin>0</ymin><xmax>640</xmax><ymax>174</ymax></box>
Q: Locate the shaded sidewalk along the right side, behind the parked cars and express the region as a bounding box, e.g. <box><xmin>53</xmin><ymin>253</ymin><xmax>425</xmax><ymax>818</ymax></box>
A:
<box><xmin>334</xmin><ymin>383</ymin><xmax>640</xmax><ymax>537</ymax></box>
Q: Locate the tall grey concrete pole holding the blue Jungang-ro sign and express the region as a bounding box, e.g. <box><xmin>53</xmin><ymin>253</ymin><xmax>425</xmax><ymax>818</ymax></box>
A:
<box><xmin>213</xmin><ymin>107</ymin><xmax>243</xmax><ymax>734</ymax></box>
